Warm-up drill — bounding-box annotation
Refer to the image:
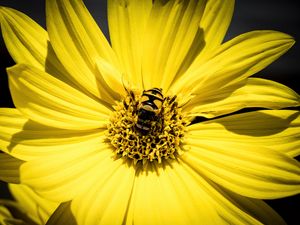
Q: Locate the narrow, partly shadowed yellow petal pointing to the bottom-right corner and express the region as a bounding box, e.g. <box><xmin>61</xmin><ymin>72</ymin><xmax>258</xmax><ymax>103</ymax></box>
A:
<box><xmin>178</xmin><ymin>160</ymin><xmax>285</xmax><ymax>225</ymax></box>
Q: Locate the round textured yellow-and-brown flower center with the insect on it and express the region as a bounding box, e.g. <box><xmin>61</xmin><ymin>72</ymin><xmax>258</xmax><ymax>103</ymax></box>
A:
<box><xmin>107</xmin><ymin>88</ymin><xmax>189</xmax><ymax>164</ymax></box>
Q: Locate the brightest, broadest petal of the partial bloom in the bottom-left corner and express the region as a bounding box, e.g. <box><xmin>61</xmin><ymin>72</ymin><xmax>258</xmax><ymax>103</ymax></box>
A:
<box><xmin>9</xmin><ymin>184</ymin><xmax>58</xmax><ymax>224</ymax></box>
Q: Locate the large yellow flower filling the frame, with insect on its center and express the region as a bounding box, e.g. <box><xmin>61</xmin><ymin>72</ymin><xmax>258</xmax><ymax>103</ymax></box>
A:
<box><xmin>0</xmin><ymin>0</ymin><xmax>300</xmax><ymax>225</ymax></box>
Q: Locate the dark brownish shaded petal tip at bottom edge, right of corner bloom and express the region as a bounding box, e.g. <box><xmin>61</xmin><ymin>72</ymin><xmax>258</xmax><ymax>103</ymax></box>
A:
<box><xmin>46</xmin><ymin>201</ymin><xmax>78</xmax><ymax>225</ymax></box>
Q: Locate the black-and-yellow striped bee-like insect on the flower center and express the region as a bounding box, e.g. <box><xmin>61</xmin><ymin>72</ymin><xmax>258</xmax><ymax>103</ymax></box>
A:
<box><xmin>136</xmin><ymin>88</ymin><xmax>164</xmax><ymax>134</ymax></box>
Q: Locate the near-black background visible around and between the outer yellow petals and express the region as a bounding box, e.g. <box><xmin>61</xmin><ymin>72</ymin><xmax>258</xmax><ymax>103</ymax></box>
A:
<box><xmin>0</xmin><ymin>0</ymin><xmax>300</xmax><ymax>225</ymax></box>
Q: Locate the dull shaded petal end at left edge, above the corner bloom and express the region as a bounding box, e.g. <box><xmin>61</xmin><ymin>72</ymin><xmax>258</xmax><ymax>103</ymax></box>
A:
<box><xmin>0</xmin><ymin>153</ymin><xmax>24</xmax><ymax>184</ymax></box>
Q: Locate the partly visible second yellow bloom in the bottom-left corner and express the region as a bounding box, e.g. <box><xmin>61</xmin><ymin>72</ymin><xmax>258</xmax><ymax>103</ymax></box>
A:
<box><xmin>0</xmin><ymin>184</ymin><xmax>58</xmax><ymax>225</ymax></box>
